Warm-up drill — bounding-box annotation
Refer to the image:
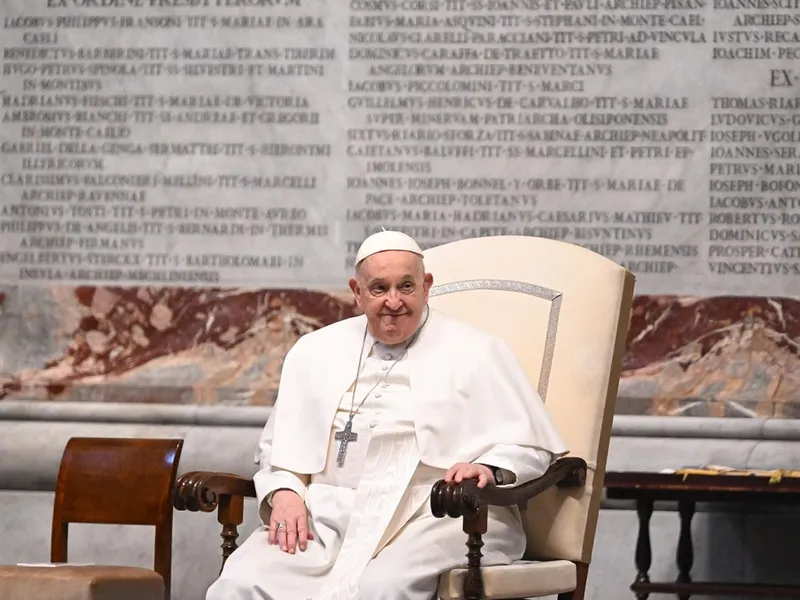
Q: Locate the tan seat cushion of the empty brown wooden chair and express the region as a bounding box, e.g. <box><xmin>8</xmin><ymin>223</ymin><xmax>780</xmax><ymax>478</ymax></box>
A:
<box><xmin>0</xmin><ymin>565</ymin><xmax>164</xmax><ymax>600</ymax></box>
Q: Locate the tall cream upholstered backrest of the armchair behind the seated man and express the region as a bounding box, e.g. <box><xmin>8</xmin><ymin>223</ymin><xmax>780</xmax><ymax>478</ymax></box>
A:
<box><xmin>425</xmin><ymin>236</ymin><xmax>634</xmax><ymax>563</ymax></box>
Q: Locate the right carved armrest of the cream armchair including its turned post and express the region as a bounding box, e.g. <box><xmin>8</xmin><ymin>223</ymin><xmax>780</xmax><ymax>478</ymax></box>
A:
<box><xmin>431</xmin><ymin>456</ymin><xmax>587</xmax><ymax>600</ymax></box>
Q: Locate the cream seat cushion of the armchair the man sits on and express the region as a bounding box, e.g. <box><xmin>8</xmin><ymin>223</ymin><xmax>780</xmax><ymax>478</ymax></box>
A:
<box><xmin>439</xmin><ymin>560</ymin><xmax>577</xmax><ymax>600</ymax></box>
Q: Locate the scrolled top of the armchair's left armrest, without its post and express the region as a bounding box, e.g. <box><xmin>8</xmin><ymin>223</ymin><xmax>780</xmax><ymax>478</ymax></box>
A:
<box><xmin>173</xmin><ymin>471</ymin><xmax>256</xmax><ymax>512</ymax></box>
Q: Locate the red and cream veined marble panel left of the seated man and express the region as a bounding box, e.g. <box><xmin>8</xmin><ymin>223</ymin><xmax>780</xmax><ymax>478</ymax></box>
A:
<box><xmin>0</xmin><ymin>287</ymin><xmax>354</xmax><ymax>406</ymax></box>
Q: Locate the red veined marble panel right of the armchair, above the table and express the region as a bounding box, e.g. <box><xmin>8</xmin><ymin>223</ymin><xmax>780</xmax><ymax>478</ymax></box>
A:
<box><xmin>617</xmin><ymin>296</ymin><xmax>800</xmax><ymax>418</ymax></box>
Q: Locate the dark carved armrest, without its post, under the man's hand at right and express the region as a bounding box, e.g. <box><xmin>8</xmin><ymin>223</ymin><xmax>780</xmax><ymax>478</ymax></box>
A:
<box><xmin>431</xmin><ymin>456</ymin><xmax>587</xmax><ymax>518</ymax></box>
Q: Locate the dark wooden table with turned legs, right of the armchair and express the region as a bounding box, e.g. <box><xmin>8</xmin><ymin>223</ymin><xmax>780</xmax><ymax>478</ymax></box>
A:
<box><xmin>605</xmin><ymin>471</ymin><xmax>800</xmax><ymax>600</ymax></box>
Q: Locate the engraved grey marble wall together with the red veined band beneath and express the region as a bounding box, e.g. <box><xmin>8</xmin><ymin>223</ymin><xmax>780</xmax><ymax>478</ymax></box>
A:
<box><xmin>0</xmin><ymin>0</ymin><xmax>800</xmax><ymax>418</ymax></box>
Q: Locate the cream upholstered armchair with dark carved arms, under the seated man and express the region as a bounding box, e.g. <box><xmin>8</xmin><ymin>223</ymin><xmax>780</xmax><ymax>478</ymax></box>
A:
<box><xmin>175</xmin><ymin>236</ymin><xmax>634</xmax><ymax>600</ymax></box>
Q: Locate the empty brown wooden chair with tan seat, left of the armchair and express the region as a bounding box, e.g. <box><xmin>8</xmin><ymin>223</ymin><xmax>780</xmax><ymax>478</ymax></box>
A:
<box><xmin>0</xmin><ymin>438</ymin><xmax>183</xmax><ymax>600</ymax></box>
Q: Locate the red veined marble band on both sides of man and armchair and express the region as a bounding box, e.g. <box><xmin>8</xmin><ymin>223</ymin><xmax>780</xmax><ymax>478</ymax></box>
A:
<box><xmin>0</xmin><ymin>286</ymin><xmax>800</xmax><ymax>418</ymax></box>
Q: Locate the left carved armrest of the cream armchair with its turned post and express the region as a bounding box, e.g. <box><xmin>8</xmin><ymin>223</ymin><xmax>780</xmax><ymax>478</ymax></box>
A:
<box><xmin>172</xmin><ymin>471</ymin><xmax>256</xmax><ymax>572</ymax></box>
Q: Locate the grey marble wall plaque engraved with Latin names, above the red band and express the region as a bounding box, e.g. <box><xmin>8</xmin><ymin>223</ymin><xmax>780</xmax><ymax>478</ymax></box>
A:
<box><xmin>0</xmin><ymin>0</ymin><xmax>800</xmax><ymax>295</ymax></box>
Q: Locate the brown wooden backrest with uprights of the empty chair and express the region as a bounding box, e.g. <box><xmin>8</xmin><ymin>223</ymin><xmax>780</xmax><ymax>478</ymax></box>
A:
<box><xmin>50</xmin><ymin>438</ymin><xmax>183</xmax><ymax>600</ymax></box>
